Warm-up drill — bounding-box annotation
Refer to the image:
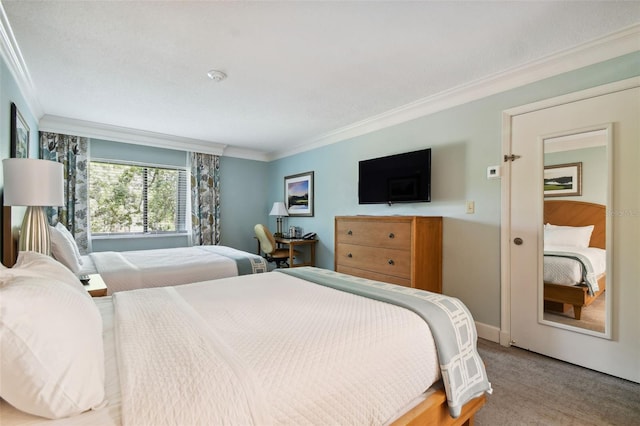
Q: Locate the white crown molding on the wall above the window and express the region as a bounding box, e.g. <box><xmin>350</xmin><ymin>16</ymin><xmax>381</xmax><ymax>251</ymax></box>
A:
<box><xmin>39</xmin><ymin>115</ymin><xmax>227</xmax><ymax>155</ymax></box>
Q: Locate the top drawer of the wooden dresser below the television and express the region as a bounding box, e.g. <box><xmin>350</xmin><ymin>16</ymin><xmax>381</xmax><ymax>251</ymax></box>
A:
<box><xmin>336</xmin><ymin>220</ymin><xmax>411</xmax><ymax>250</ymax></box>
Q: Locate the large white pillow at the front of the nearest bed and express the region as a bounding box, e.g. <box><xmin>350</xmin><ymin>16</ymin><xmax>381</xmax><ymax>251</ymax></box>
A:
<box><xmin>0</xmin><ymin>270</ymin><xmax>105</xmax><ymax>419</ymax></box>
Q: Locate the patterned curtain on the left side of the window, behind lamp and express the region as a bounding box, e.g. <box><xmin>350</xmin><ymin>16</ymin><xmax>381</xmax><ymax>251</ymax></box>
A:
<box><xmin>40</xmin><ymin>132</ymin><xmax>89</xmax><ymax>254</ymax></box>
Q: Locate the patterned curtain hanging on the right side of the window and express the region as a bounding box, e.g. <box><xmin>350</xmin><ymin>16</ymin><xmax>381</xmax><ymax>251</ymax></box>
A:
<box><xmin>190</xmin><ymin>152</ymin><xmax>220</xmax><ymax>245</ymax></box>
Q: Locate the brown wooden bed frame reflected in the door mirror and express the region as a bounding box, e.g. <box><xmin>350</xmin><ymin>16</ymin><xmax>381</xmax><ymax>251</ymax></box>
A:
<box><xmin>544</xmin><ymin>200</ymin><xmax>607</xmax><ymax>320</ymax></box>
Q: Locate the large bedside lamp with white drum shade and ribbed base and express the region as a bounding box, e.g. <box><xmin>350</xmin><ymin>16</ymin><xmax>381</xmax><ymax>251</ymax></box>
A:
<box><xmin>2</xmin><ymin>158</ymin><xmax>64</xmax><ymax>255</ymax></box>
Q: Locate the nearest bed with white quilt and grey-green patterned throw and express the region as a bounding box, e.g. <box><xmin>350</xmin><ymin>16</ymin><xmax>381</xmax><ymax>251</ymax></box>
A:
<box><xmin>0</xmin><ymin>255</ymin><xmax>490</xmax><ymax>426</ymax></box>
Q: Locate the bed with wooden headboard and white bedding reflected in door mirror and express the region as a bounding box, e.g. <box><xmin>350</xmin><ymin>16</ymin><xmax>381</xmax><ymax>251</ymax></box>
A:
<box><xmin>544</xmin><ymin>200</ymin><xmax>607</xmax><ymax>332</ymax></box>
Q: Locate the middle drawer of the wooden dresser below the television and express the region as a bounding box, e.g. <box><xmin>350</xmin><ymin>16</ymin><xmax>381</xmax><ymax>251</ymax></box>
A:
<box><xmin>336</xmin><ymin>244</ymin><xmax>411</xmax><ymax>280</ymax></box>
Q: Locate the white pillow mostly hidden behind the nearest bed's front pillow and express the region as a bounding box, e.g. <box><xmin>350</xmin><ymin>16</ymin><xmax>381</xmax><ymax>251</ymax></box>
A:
<box><xmin>3</xmin><ymin>251</ymin><xmax>91</xmax><ymax>299</ymax></box>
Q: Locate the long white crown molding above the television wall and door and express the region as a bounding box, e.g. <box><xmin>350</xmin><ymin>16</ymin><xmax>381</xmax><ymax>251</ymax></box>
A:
<box><xmin>268</xmin><ymin>24</ymin><xmax>640</xmax><ymax>161</ymax></box>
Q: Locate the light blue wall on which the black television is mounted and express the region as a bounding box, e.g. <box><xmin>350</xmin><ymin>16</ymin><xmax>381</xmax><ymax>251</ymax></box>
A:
<box><xmin>265</xmin><ymin>53</ymin><xmax>640</xmax><ymax>327</ymax></box>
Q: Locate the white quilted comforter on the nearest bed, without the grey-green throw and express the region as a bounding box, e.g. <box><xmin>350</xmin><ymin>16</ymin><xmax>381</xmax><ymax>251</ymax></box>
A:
<box><xmin>114</xmin><ymin>273</ymin><xmax>440</xmax><ymax>425</ymax></box>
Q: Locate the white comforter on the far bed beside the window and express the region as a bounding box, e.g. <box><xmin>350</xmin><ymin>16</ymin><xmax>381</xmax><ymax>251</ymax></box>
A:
<box><xmin>83</xmin><ymin>246</ymin><xmax>267</xmax><ymax>294</ymax></box>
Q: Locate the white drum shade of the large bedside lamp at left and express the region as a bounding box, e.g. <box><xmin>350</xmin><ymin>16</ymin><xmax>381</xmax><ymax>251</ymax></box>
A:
<box><xmin>2</xmin><ymin>158</ymin><xmax>64</xmax><ymax>207</ymax></box>
